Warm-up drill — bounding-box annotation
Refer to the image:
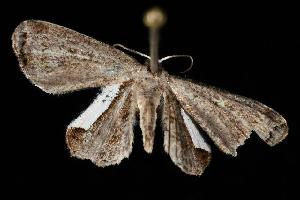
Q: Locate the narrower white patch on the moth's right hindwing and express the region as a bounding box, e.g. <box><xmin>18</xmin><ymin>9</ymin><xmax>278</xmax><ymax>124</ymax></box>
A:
<box><xmin>180</xmin><ymin>108</ymin><xmax>211</xmax><ymax>152</ymax></box>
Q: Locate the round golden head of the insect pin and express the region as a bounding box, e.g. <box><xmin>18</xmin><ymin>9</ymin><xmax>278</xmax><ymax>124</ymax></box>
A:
<box><xmin>143</xmin><ymin>7</ymin><xmax>167</xmax><ymax>28</ymax></box>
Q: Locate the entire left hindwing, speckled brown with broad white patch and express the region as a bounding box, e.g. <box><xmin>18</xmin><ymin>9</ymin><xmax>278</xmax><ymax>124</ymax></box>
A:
<box><xmin>66</xmin><ymin>82</ymin><xmax>137</xmax><ymax>167</ymax></box>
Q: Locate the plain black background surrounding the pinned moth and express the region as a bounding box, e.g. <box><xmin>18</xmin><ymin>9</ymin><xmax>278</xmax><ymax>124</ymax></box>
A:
<box><xmin>0</xmin><ymin>1</ymin><xmax>300</xmax><ymax>199</ymax></box>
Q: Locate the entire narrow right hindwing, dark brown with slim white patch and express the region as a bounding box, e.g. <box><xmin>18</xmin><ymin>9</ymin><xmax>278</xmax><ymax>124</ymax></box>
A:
<box><xmin>162</xmin><ymin>91</ymin><xmax>211</xmax><ymax>175</ymax></box>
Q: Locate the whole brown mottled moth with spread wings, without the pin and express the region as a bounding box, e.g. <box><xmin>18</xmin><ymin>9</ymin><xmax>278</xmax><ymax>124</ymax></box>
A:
<box><xmin>12</xmin><ymin>16</ymin><xmax>288</xmax><ymax>175</ymax></box>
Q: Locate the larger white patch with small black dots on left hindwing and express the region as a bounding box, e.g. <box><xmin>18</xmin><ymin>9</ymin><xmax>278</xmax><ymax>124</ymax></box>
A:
<box><xmin>69</xmin><ymin>84</ymin><xmax>120</xmax><ymax>130</ymax></box>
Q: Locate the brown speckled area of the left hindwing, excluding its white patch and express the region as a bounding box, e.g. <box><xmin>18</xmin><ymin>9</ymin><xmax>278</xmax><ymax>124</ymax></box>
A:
<box><xmin>66</xmin><ymin>82</ymin><xmax>137</xmax><ymax>167</ymax></box>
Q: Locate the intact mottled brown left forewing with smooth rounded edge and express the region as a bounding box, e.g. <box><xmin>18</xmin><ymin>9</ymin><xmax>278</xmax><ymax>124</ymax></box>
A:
<box><xmin>12</xmin><ymin>20</ymin><xmax>146</xmax><ymax>93</ymax></box>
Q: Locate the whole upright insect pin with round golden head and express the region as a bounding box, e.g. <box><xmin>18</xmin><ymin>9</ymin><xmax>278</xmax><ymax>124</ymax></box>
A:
<box><xmin>143</xmin><ymin>8</ymin><xmax>167</xmax><ymax>73</ymax></box>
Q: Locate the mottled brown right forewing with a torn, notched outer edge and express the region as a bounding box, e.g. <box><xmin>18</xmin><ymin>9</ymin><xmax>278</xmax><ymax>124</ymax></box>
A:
<box><xmin>169</xmin><ymin>77</ymin><xmax>288</xmax><ymax>156</ymax></box>
